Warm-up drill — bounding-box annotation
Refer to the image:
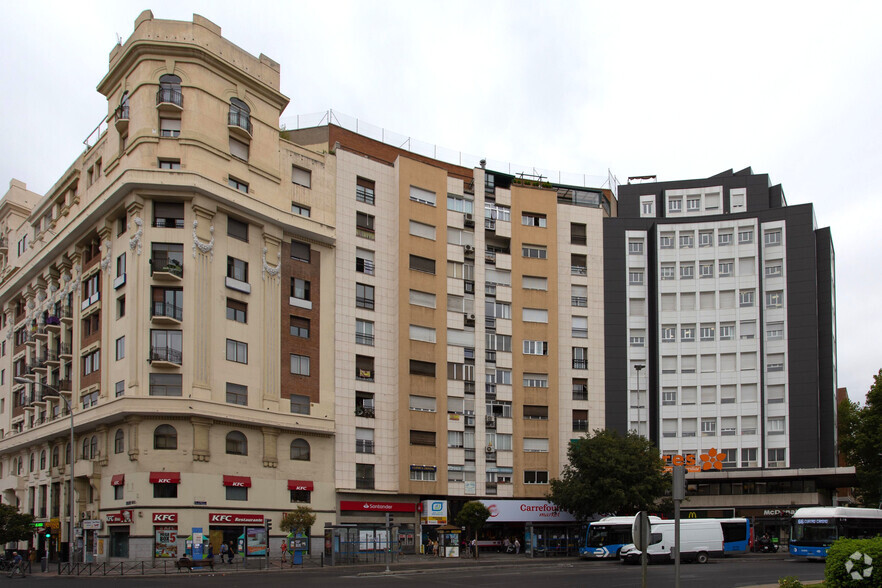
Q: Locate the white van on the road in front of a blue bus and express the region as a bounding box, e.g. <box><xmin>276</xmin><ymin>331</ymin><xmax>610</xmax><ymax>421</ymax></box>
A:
<box><xmin>621</xmin><ymin>519</ymin><xmax>723</xmax><ymax>563</ymax></box>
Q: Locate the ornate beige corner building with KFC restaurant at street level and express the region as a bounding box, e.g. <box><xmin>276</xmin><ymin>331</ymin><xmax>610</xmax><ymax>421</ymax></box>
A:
<box><xmin>0</xmin><ymin>11</ymin><xmax>336</xmax><ymax>561</ymax></box>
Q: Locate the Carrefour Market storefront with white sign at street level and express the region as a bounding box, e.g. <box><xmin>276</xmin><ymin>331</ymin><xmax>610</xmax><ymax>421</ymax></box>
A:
<box><xmin>479</xmin><ymin>499</ymin><xmax>581</xmax><ymax>557</ymax></box>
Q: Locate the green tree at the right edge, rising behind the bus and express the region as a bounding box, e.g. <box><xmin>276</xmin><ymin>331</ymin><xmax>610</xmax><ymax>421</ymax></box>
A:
<box><xmin>839</xmin><ymin>370</ymin><xmax>882</xmax><ymax>508</ymax></box>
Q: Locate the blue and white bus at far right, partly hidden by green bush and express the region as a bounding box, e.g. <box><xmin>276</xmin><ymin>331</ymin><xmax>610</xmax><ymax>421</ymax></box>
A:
<box><xmin>790</xmin><ymin>506</ymin><xmax>882</xmax><ymax>559</ymax></box>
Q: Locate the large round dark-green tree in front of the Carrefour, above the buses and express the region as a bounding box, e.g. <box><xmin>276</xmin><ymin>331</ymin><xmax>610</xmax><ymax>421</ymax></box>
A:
<box><xmin>548</xmin><ymin>429</ymin><xmax>671</xmax><ymax>520</ymax></box>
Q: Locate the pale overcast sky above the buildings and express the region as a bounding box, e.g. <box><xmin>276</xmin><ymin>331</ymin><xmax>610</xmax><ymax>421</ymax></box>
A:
<box><xmin>0</xmin><ymin>0</ymin><xmax>882</xmax><ymax>401</ymax></box>
